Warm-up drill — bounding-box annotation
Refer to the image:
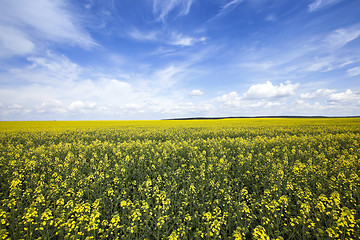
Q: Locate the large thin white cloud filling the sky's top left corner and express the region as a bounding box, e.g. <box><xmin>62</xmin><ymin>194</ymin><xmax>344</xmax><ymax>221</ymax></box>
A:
<box><xmin>0</xmin><ymin>0</ymin><xmax>97</xmax><ymax>57</ymax></box>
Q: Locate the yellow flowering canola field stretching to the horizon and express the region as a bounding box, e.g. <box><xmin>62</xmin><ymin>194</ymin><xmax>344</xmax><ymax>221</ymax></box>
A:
<box><xmin>0</xmin><ymin>118</ymin><xmax>360</xmax><ymax>240</ymax></box>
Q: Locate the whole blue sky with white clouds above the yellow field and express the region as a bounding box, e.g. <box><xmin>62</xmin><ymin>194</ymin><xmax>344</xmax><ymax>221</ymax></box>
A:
<box><xmin>0</xmin><ymin>0</ymin><xmax>360</xmax><ymax>120</ymax></box>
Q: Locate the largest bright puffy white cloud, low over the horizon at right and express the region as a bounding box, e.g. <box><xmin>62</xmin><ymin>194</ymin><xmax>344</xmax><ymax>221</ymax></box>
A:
<box><xmin>244</xmin><ymin>81</ymin><xmax>299</xmax><ymax>99</ymax></box>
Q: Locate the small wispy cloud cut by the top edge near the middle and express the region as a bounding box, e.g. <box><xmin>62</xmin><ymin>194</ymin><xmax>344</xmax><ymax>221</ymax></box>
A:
<box><xmin>153</xmin><ymin>0</ymin><xmax>193</xmax><ymax>21</ymax></box>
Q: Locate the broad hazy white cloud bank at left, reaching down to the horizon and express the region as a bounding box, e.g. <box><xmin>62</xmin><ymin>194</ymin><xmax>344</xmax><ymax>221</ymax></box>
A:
<box><xmin>0</xmin><ymin>53</ymin><xmax>205</xmax><ymax>120</ymax></box>
